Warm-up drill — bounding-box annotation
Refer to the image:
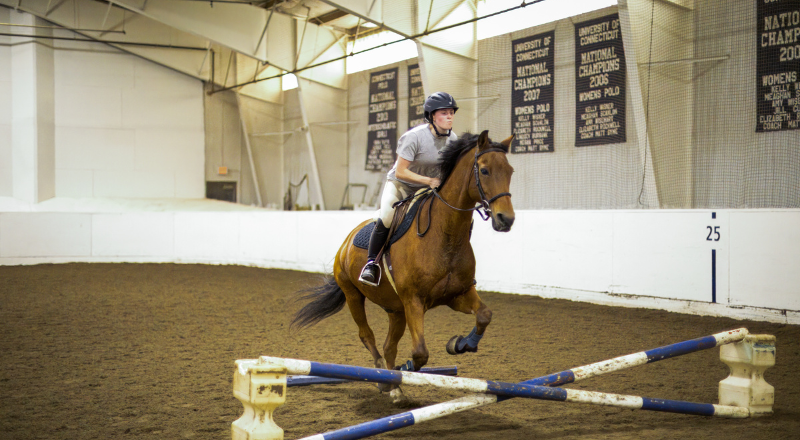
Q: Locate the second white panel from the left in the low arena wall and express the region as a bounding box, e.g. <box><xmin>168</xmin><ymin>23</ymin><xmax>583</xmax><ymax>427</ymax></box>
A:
<box><xmin>92</xmin><ymin>213</ymin><xmax>175</xmax><ymax>257</ymax></box>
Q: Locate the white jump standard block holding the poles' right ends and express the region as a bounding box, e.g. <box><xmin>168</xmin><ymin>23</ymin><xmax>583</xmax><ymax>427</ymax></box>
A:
<box><xmin>719</xmin><ymin>335</ymin><xmax>775</xmax><ymax>417</ymax></box>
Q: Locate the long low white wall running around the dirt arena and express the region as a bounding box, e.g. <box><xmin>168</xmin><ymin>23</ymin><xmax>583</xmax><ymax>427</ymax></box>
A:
<box><xmin>0</xmin><ymin>207</ymin><xmax>800</xmax><ymax>324</ymax></box>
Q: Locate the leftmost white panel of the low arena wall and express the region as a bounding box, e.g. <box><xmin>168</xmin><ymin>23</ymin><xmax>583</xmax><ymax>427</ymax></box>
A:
<box><xmin>0</xmin><ymin>213</ymin><xmax>92</xmax><ymax>258</ymax></box>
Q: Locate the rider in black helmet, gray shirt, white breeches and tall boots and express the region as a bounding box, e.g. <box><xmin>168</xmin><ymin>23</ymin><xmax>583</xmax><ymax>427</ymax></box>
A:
<box><xmin>358</xmin><ymin>92</ymin><xmax>458</xmax><ymax>286</ymax></box>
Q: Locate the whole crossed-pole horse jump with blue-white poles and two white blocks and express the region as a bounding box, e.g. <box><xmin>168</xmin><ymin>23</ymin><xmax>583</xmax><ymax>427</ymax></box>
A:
<box><xmin>232</xmin><ymin>328</ymin><xmax>775</xmax><ymax>440</ymax></box>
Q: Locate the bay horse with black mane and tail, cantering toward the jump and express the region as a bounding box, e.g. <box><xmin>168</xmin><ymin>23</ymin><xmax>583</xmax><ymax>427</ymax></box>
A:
<box><xmin>292</xmin><ymin>130</ymin><xmax>514</xmax><ymax>391</ymax></box>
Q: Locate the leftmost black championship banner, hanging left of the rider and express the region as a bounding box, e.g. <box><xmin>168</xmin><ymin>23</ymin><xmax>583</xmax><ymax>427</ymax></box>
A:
<box><xmin>365</xmin><ymin>67</ymin><xmax>397</xmax><ymax>171</ymax></box>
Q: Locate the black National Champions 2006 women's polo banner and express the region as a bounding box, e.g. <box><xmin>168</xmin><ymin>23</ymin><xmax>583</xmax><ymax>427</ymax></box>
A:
<box><xmin>575</xmin><ymin>14</ymin><xmax>626</xmax><ymax>147</ymax></box>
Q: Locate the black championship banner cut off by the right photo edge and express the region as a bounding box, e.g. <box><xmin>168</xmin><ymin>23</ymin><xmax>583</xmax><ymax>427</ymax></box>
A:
<box><xmin>756</xmin><ymin>0</ymin><xmax>800</xmax><ymax>132</ymax></box>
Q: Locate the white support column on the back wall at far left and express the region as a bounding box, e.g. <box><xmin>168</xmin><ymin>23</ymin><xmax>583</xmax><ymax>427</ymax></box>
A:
<box><xmin>10</xmin><ymin>11</ymin><xmax>56</xmax><ymax>203</ymax></box>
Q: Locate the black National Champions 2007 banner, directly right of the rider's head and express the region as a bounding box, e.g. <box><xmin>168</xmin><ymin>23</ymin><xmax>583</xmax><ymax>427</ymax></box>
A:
<box><xmin>510</xmin><ymin>31</ymin><xmax>555</xmax><ymax>153</ymax></box>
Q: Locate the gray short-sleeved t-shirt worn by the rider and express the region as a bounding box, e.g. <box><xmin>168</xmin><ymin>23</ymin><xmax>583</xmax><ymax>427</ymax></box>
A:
<box><xmin>386</xmin><ymin>124</ymin><xmax>458</xmax><ymax>191</ymax></box>
